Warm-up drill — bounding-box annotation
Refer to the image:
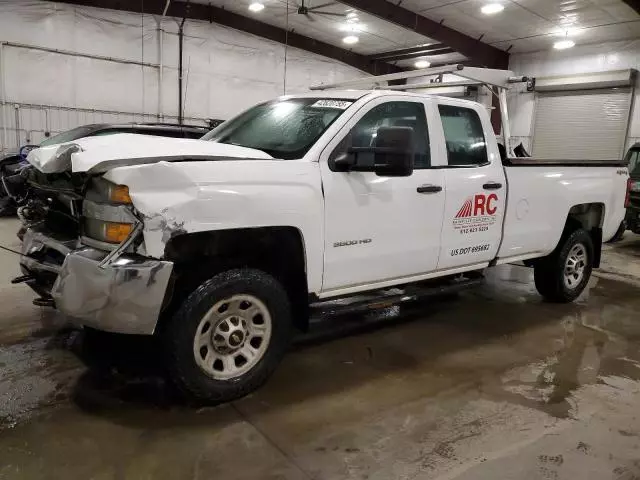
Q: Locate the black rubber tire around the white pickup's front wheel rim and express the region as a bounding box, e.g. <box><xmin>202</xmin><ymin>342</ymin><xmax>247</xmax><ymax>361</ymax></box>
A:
<box><xmin>162</xmin><ymin>268</ymin><xmax>292</xmax><ymax>404</ymax></box>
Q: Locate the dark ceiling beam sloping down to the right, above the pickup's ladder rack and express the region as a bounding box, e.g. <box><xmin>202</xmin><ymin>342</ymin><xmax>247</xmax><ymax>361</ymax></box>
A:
<box><xmin>339</xmin><ymin>0</ymin><xmax>508</xmax><ymax>68</ymax></box>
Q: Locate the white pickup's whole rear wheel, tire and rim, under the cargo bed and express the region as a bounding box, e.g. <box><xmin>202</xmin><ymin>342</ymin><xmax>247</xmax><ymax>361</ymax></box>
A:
<box><xmin>534</xmin><ymin>229</ymin><xmax>594</xmax><ymax>303</ymax></box>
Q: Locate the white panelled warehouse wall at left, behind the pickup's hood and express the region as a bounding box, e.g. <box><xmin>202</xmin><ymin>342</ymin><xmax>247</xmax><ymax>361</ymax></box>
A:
<box><xmin>0</xmin><ymin>0</ymin><xmax>363</xmax><ymax>150</ymax></box>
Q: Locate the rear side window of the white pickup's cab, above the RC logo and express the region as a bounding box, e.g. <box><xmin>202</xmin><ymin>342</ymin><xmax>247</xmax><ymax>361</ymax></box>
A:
<box><xmin>438</xmin><ymin>105</ymin><xmax>488</xmax><ymax>166</ymax></box>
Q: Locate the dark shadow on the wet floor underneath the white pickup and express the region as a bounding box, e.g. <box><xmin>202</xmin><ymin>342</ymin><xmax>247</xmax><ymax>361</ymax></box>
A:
<box><xmin>63</xmin><ymin>284</ymin><xmax>577</xmax><ymax>428</ymax></box>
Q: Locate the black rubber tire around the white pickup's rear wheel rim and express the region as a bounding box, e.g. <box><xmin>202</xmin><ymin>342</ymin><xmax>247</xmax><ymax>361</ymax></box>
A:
<box><xmin>534</xmin><ymin>228</ymin><xmax>594</xmax><ymax>303</ymax></box>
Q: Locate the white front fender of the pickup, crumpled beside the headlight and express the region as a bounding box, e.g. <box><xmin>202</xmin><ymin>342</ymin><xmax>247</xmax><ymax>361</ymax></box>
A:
<box><xmin>104</xmin><ymin>159</ymin><xmax>324</xmax><ymax>289</ymax></box>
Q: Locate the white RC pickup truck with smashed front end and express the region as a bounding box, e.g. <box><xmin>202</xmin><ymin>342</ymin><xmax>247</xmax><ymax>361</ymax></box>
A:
<box><xmin>16</xmin><ymin>64</ymin><xmax>628</xmax><ymax>402</ymax></box>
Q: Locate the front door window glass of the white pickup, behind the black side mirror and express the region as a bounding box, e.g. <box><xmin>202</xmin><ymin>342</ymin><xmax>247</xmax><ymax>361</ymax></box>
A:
<box><xmin>331</xmin><ymin>102</ymin><xmax>431</xmax><ymax>169</ymax></box>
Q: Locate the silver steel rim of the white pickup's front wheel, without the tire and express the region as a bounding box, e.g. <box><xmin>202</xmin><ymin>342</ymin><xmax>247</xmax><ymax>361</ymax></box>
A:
<box><xmin>193</xmin><ymin>295</ymin><xmax>272</xmax><ymax>380</ymax></box>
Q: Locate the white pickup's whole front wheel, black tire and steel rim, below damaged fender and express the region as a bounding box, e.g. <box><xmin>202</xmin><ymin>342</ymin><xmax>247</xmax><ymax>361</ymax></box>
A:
<box><xmin>163</xmin><ymin>269</ymin><xmax>292</xmax><ymax>403</ymax></box>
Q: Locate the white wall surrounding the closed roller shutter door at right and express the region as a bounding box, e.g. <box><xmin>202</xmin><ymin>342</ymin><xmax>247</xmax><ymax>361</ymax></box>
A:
<box><xmin>509</xmin><ymin>40</ymin><xmax>640</xmax><ymax>155</ymax></box>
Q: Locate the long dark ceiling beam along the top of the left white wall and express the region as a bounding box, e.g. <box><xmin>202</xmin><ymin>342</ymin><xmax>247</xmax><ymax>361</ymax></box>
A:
<box><xmin>51</xmin><ymin>0</ymin><xmax>402</xmax><ymax>75</ymax></box>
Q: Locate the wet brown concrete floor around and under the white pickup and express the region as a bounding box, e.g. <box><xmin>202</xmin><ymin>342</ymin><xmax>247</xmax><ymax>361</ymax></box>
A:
<box><xmin>0</xmin><ymin>221</ymin><xmax>640</xmax><ymax>480</ymax></box>
